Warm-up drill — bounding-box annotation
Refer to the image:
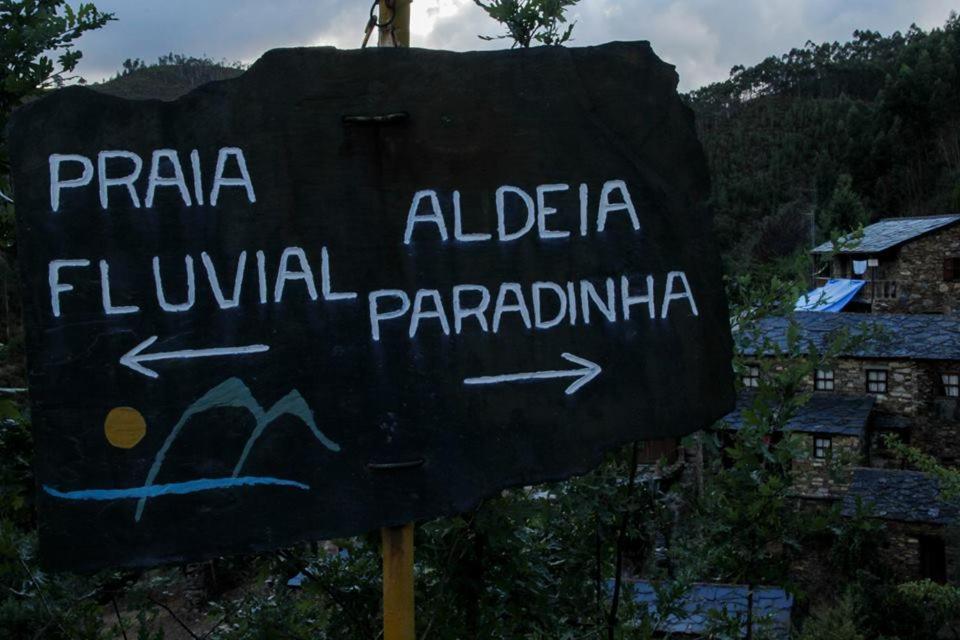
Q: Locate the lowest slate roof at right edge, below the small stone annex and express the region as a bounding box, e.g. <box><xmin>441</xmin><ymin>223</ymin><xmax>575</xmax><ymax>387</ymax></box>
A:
<box><xmin>841</xmin><ymin>469</ymin><xmax>960</xmax><ymax>525</ymax></box>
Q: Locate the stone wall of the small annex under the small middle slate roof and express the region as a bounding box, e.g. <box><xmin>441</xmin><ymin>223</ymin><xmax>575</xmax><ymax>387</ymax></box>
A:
<box><xmin>793</xmin><ymin>433</ymin><xmax>863</xmax><ymax>498</ymax></box>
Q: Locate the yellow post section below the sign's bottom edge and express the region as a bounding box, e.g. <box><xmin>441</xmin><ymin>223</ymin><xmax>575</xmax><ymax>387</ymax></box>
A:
<box><xmin>380</xmin><ymin>523</ymin><xmax>414</xmax><ymax>640</ymax></box>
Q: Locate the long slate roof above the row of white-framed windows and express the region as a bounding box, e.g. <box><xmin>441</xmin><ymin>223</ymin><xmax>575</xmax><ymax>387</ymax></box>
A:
<box><xmin>734</xmin><ymin>311</ymin><xmax>960</xmax><ymax>360</ymax></box>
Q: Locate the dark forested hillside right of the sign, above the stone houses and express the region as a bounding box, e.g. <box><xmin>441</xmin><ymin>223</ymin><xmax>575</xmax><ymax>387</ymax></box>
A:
<box><xmin>687</xmin><ymin>14</ymin><xmax>960</xmax><ymax>270</ymax></box>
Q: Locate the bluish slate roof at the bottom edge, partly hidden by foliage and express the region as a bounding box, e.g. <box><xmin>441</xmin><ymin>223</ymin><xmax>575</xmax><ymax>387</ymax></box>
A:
<box><xmin>630</xmin><ymin>580</ymin><xmax>793</xmax><ymax>640</ymax></box>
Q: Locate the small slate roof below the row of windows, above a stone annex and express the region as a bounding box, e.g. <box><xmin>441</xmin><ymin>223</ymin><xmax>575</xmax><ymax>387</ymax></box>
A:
<box><xmin>723</xmin><ymin>393</ymin><xmax>875</xmax><ymax>437</ymax></box>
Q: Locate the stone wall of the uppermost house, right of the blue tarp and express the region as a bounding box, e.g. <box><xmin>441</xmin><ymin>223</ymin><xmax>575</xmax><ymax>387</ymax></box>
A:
<box><xmin>873</xmin><ymin>224</ymin><xmax>960</xmax><ymax>313</ymax></box>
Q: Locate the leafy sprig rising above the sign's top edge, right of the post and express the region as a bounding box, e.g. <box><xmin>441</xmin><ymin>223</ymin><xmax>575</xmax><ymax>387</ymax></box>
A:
<box><xmin>473</xmin><ymin>0</ymin><xmax>580</xmax><ymax>47</ymax></box>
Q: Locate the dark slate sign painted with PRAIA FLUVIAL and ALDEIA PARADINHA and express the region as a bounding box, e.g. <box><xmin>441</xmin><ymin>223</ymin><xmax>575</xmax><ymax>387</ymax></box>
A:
<box><xmin>10</xmin><ymin>43</ymin><xmax>733</xmax><ymax>569</ymax></box>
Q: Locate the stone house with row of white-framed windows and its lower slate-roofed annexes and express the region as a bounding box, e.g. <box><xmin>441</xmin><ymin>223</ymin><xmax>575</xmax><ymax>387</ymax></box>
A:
<box><xmin>740</xmin><ymin>312</ymin><xmax>960</xmax><ymax>580</ymax></box>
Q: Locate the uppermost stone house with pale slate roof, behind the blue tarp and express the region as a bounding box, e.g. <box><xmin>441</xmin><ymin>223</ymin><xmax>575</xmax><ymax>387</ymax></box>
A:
<box><xmin>811</xmin><ymin>214</ymin><xmax>960</xmax><ymax>313</ymax></box>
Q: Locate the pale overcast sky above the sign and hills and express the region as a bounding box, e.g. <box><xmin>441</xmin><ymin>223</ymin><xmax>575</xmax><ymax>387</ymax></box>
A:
<box><xmin>80</xmin><ymin>0</ymin><xmax>960</xmax><ymax>90</ymax></box>
